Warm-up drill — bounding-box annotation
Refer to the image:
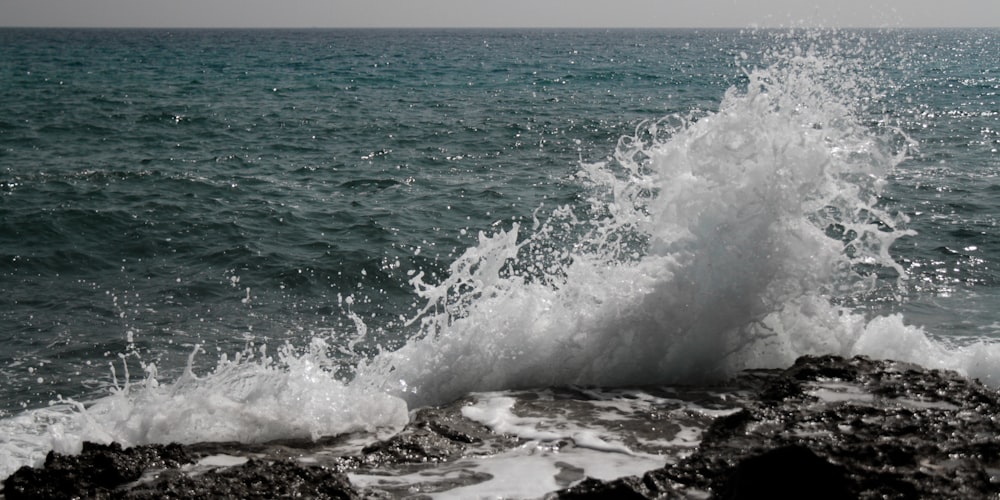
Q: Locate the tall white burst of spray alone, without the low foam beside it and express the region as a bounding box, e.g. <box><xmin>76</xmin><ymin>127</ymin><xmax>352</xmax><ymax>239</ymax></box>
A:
<box><xmin>360</xmin><ymin>39</ymin><xmax>906</xmax><ymax>405</ymax></box>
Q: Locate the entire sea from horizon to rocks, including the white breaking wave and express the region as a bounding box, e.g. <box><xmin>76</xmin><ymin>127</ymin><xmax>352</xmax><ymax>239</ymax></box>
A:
<box><xmin>0</xmin><ymin>29</ymin><xmax>1000</xmax><ymax>492</ymax></box>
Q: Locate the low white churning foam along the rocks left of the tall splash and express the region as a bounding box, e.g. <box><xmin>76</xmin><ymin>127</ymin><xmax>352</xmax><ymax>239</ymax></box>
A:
<box><xmin>0</xmin><ymin>341</ymin><xmax>408</xmax><ymax>477</ymax></box>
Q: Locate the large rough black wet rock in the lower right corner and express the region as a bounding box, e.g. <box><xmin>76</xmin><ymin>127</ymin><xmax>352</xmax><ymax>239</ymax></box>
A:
<box><xmin>552</xmin><ymin>356</ymin><xmax>1000</xmax><ymax>499</ymax></box>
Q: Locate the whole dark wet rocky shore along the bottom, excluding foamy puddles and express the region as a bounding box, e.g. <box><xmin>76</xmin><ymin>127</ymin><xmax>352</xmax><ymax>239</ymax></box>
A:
<box><xmin>3</xmin><ymin>356</ymin><xmax>1000</xmax><ymax>500</ymax></box>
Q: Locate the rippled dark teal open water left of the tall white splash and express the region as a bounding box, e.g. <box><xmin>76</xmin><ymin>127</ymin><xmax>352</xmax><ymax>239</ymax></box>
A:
<box><xmin>0</xmin><ymin>30</ymin><xmax>752</xmax><ymax>411</ymax></box>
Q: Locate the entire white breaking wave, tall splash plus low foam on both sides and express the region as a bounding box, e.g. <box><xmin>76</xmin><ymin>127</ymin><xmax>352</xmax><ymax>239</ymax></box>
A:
<box><xmin>0</xmin><ymin>30</ymin><xmax>1000</xmax><ymax>476</ymax></box>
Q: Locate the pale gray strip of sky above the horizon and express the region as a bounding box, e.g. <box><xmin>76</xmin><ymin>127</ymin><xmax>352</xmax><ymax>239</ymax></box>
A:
<box><xmin>0</xmin><ymin>0</ymin><xmax>1000</xmax><ymax>27</ymax></box>
